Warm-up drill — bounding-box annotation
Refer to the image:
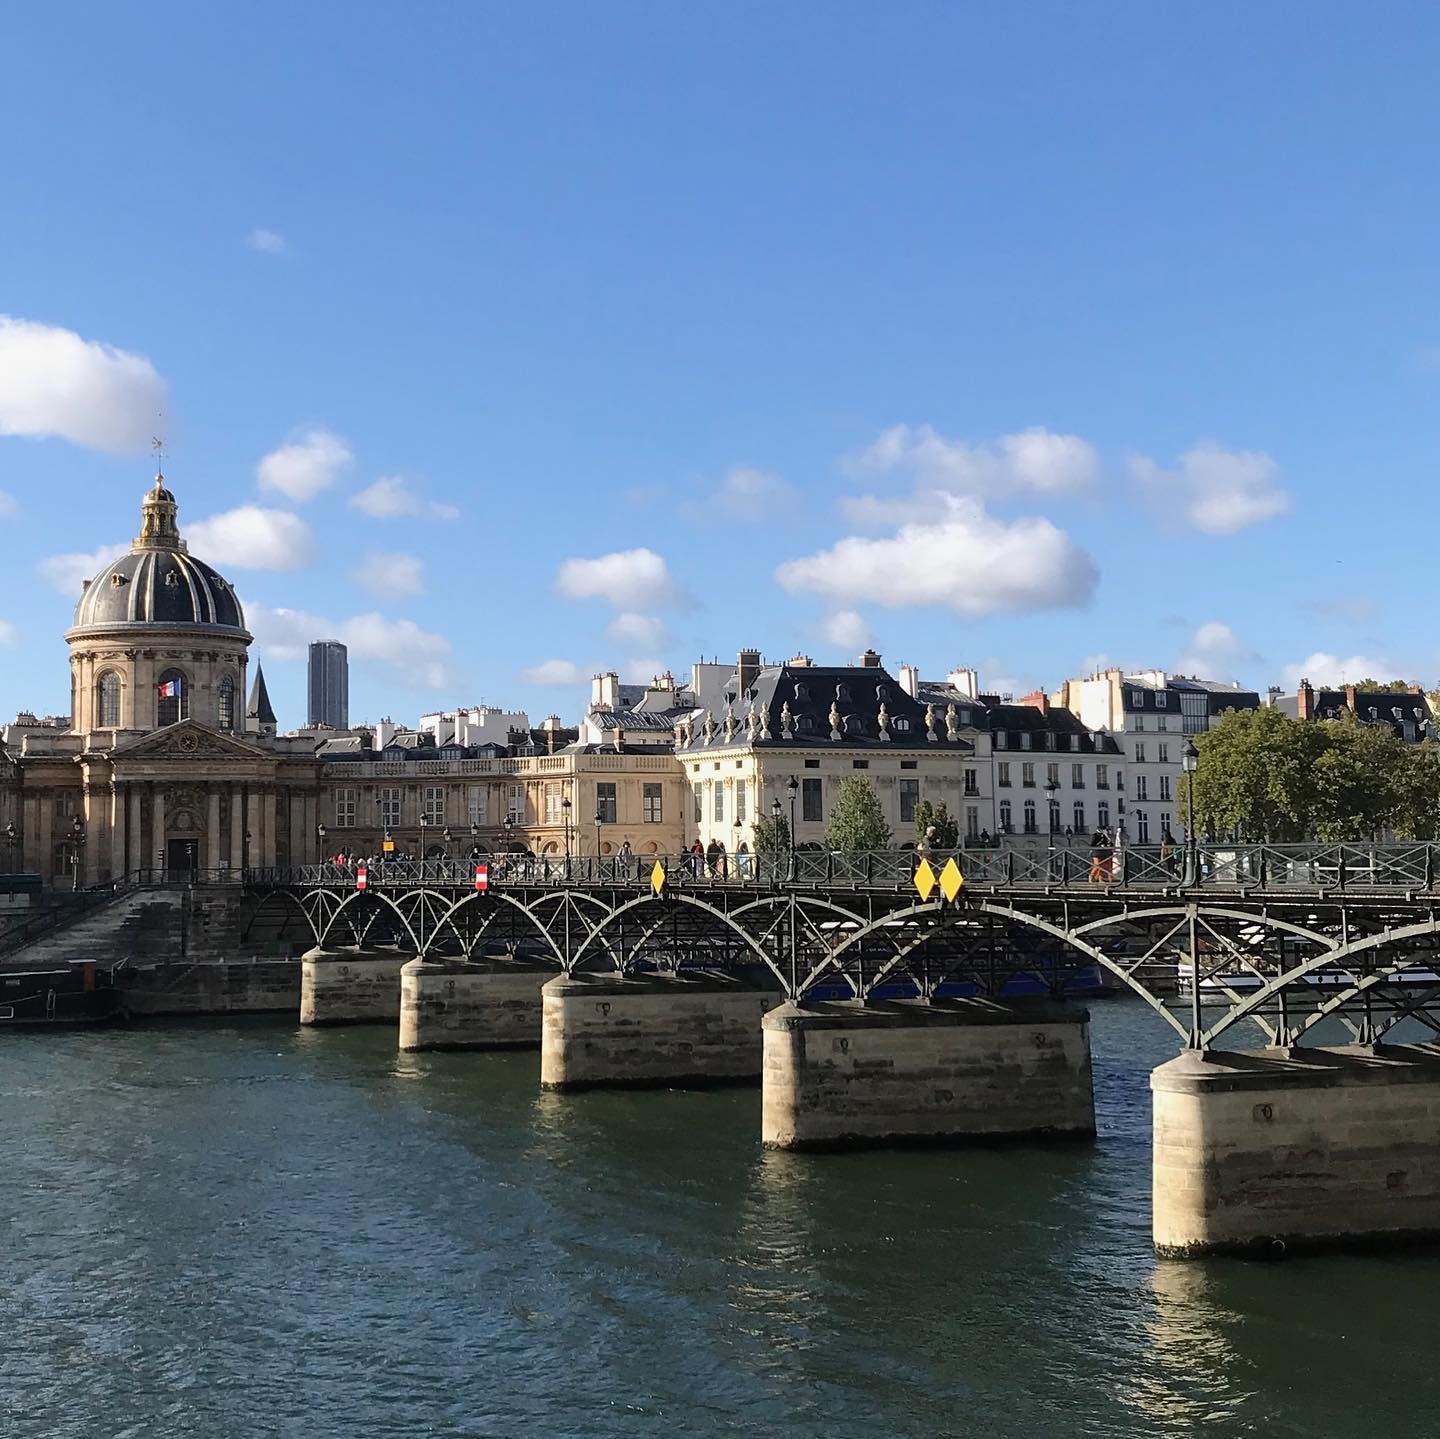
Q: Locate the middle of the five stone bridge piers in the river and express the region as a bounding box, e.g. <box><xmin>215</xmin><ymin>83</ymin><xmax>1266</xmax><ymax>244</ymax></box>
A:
<box><xmin>540</xmin><ymin>974</ymin><xmax>779</xmax><ymax>1089</ymax></box>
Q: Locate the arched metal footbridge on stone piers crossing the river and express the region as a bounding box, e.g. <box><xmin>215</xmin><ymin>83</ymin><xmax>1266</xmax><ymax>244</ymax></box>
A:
<box><xmin>246</xmin><ymin>844</ymin><xmax>1440</xmax><ymax>1255</ymax></box>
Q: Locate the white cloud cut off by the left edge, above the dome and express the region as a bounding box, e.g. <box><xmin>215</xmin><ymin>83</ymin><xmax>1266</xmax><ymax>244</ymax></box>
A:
<box><xmin>0</xmin><ymin>314</ymin><xmax>166</xmax><ymax>454</ymax></box>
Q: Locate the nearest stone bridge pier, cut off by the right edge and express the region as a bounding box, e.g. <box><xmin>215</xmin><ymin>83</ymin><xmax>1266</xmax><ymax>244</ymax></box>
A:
<box><xmin>1151</xmin><ymin>1044</ymin><xmax>1440</xmax><ymax>1258</ymax></box>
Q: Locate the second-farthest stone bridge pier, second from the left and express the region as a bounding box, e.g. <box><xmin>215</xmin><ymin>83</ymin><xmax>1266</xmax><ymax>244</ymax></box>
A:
<box><xmin>400</xmin><ymin>959</ymin><xmax>554</xmax><ymax>1050</ymax></box>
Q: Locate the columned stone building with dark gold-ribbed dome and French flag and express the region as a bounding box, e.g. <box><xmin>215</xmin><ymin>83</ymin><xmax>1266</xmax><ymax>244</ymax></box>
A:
<box><xmin>3</xmin><ymin>475</ymin><xmax>320</xmax><ymax>883</ymax></box>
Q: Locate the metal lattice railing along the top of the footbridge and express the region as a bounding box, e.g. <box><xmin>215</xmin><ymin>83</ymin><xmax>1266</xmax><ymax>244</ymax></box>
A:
<box><xmin>250</xmin><ymin>843</ymin><xmax>1440</xmax><ymax>895</ymax></box>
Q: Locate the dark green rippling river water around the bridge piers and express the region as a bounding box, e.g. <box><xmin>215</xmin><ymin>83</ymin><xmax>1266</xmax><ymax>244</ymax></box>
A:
<box><xmin>0</xmin><ymin>1001</ymin><xmax>1440</xmax><ymax>1439</ymax></box>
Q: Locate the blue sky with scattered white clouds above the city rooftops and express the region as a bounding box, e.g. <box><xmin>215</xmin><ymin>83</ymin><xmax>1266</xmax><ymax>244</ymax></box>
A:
<box><xmin>0</xmin><ymin>3</ymin><xmax>1440</xmax><ymax>725</ymax></box>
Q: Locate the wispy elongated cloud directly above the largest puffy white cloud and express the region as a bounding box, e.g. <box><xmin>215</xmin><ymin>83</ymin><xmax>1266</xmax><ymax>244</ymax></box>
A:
<box><xmin>850</xmin><ymin>425</ymin><xmax>1099</xmax><ymax>497</ymax></box>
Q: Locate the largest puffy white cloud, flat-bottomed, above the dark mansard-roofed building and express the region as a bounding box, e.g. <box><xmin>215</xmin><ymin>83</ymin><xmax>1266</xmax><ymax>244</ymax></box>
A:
<box><xmin>775</xmin><ymin>500</ymin><xmax>1097</xmax><ymax>615</ymax></box>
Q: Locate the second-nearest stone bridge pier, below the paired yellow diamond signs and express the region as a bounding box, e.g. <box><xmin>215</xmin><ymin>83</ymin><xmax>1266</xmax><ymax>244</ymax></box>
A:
<box><xmin>760</xmin><ymin>1000</ymin><xmax>1094</xmax><ymax>1149</ymax></box>
